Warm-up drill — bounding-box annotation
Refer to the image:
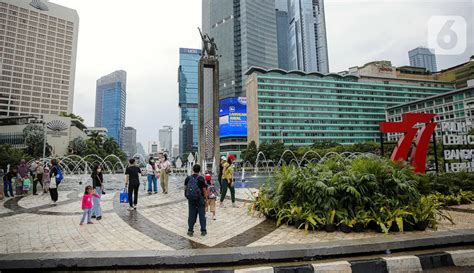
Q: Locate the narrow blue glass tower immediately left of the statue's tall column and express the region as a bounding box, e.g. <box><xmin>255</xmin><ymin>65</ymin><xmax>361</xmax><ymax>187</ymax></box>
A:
<box><xmin>178</xmin><ymin>48</ymin><xmax>201</xmax><ymax>154</ymax></box>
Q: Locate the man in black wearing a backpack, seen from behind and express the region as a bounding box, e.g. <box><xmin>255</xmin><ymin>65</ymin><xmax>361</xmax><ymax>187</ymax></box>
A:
<box><xmin>184</xmin><ymin>164</ymin><xmax>207</xmax><ymax>236</ymax></box>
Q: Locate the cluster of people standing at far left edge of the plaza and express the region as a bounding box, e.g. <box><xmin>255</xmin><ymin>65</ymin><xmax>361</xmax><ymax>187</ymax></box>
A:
<box><xmin>3</xmin><ymin>156</ymin><xmax>63</xmax><ymax>204</ymax></box>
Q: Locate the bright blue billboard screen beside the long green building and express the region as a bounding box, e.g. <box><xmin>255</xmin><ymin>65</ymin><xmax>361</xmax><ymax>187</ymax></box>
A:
<box><xmin>219</xmin><ymin>97</ymin><xmax>247</xmax><ymax>138</ymax></box>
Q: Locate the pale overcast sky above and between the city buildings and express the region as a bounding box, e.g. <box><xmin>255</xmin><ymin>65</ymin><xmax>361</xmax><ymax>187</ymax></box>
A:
<box><xmin>51</xmin><ymin>0</ymin><xmax>474</xmax><ymax>149</ymax></box>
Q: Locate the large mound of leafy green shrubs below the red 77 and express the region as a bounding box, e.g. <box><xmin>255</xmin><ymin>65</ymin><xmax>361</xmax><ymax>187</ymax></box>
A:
<box><xmin>253</xmin><ymin>157</ymin><xmax>458</xmax><ymax>233</ymax></box>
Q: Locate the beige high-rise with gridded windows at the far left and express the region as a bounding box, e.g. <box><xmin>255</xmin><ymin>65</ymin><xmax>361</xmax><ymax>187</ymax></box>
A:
<box><xmin>0</xmin><ymin>0</ymin><xmax>79</xmax><ymax>116</ymax></box>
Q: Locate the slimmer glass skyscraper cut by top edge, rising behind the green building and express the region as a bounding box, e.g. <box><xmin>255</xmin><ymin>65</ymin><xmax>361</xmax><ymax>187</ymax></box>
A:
<box><xmin>288</xmin><ymin>0</ymin><xmax>329</xmax><ymax>74</ymax></box>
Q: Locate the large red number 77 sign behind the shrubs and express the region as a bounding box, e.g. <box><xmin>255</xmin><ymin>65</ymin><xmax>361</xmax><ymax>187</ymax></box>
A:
<box><xmin>380</xmin><ymin>113</ymin><xmax>438</xmax><ymax>173</ymax></box>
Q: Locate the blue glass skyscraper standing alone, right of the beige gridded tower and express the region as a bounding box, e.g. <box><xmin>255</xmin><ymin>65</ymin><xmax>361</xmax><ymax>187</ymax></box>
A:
<box><xmin>94</xmin><ymin>70</ymin><xmax>127</xmax><ymax>148</ymax></box>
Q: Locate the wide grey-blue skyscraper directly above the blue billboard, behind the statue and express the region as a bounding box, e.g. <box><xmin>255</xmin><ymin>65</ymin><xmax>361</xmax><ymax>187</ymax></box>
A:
<box><xmin>202</xmin><ymin>0</ymin><xmax>278</xmax><ymax>99</ymax></box>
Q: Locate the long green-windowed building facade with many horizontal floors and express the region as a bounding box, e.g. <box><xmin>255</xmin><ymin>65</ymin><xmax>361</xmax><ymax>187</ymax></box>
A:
<box><xmin>247</xmin><ymin>68</ymin><xmax>453</xmax><ymax>146</ymax></box>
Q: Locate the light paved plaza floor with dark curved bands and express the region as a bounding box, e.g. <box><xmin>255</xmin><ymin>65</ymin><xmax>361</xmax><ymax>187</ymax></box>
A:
<box><xmin>0</xmin><ymin>174</ymin><xmax>474</xmax><ymax>254</ymax></box>
